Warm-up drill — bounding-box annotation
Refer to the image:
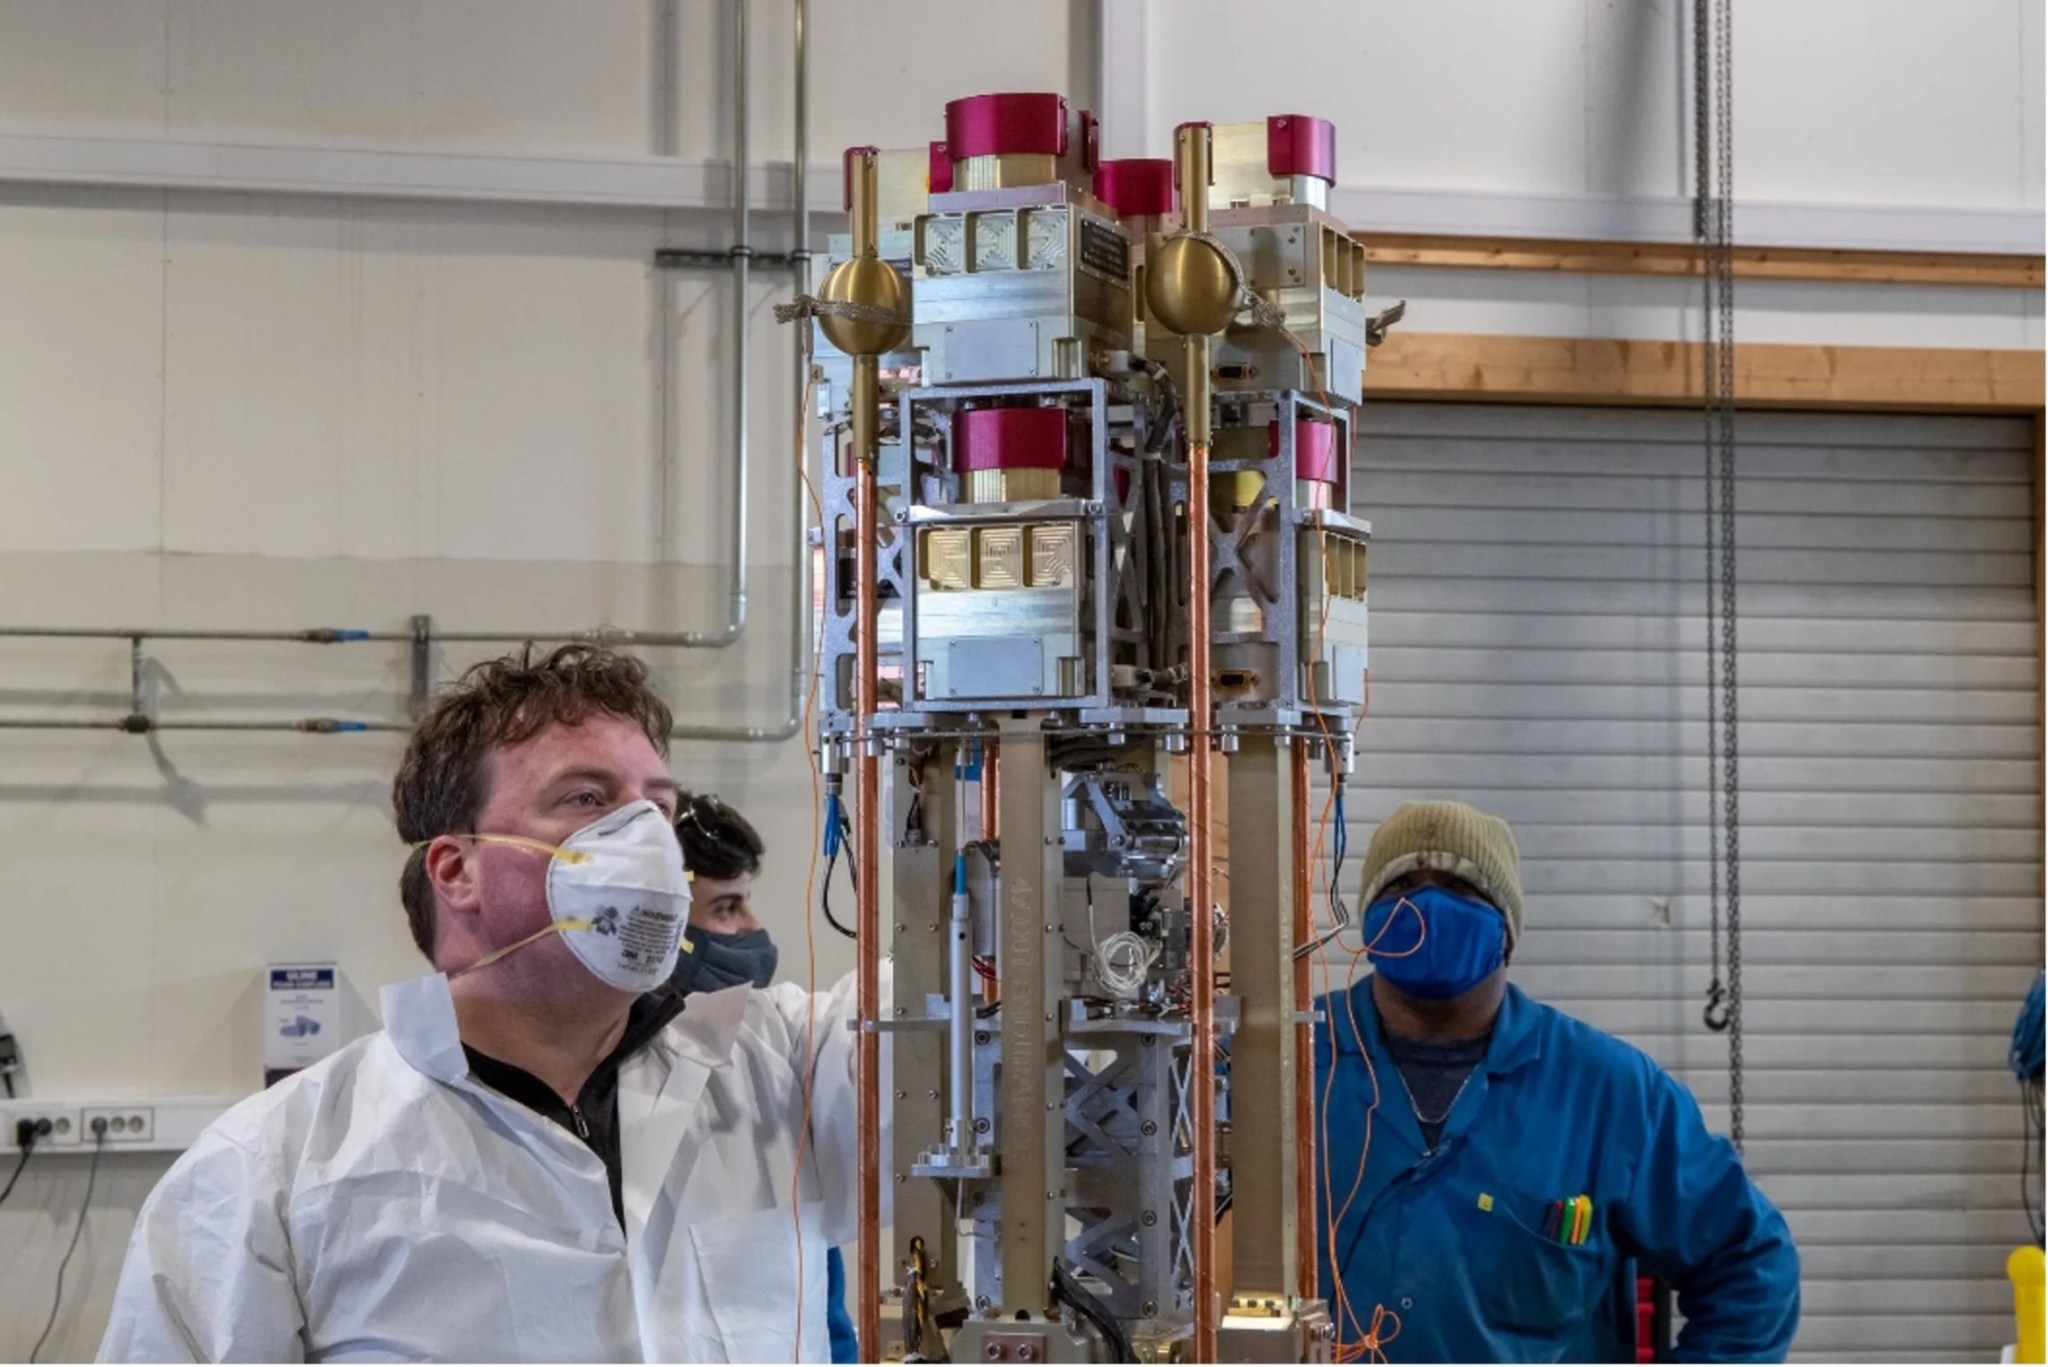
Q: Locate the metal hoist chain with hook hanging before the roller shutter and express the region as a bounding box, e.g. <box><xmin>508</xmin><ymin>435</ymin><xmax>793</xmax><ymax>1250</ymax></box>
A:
<box><xmin>1692</xmin><ymin>0</ymin><xmax>1743</xmax><ymax>1150</ymax></box>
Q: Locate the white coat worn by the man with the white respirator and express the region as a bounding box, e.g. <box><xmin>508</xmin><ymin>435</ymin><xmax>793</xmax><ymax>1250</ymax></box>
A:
<box><xmin>100</xmin><ymin>974</ymin><xmax>889</xmax><ymax>1363</ymax></box>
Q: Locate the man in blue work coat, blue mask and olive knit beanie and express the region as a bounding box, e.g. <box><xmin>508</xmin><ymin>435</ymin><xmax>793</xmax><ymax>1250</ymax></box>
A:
<box><xmin>1315</xmin><ymin>801</ymin><xmax>1798</xmax><ymax>1363</ymax></box>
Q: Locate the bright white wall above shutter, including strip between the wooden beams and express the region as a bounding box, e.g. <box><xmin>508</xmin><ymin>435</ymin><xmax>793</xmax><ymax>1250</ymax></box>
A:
<box><xmin>1138</xmin><ymin>0</ymin><xmax>2044</xmax><ymax>348</ymax></box>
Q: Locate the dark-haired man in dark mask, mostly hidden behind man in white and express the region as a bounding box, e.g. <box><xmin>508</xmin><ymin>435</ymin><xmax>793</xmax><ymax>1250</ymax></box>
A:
<box><xmin>674</xmin><ymin>793</ymin><xmax>860</xmax><ymax>1363</ymax></box>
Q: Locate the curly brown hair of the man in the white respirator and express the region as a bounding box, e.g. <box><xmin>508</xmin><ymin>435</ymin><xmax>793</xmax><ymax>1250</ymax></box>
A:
<box><xmin>391</xmin><ymin>641</ymin><xmax>674</xmax><ymax>961</ymax></box>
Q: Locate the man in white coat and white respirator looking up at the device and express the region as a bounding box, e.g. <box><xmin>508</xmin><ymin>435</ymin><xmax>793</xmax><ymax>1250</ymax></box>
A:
<box><xmin>100</xmin><ymin>646</ymin><xmax>876</xmax><ymax>1361</ymax></box>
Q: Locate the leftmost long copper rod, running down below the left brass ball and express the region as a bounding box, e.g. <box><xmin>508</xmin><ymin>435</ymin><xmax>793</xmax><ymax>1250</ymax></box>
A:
<box><xmin>852</xmin><ymin>357</ymin><xmax>883</xmax><ymax>1363</ymax></box>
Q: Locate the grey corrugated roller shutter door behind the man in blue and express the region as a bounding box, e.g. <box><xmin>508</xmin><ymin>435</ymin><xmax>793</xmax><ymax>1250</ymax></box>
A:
<box><xmin>1348</xmin><ymin>404</ymin><xmax>2042</xmax><ymax>1361</ymax></box>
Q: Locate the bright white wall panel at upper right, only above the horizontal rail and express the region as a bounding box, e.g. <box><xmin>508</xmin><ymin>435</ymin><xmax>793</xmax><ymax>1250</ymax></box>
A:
<box><xmin>1145</xmin><ymin>0</ymin><xmax>2042</xmax><ymax>209</ymax></box>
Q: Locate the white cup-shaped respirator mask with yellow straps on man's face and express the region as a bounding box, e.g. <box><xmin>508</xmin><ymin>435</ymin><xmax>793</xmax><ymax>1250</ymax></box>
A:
<box><xmin>449</xmin><ymin>799</ymin><xmax>690</xmax><ymax>992</ymax></box>
